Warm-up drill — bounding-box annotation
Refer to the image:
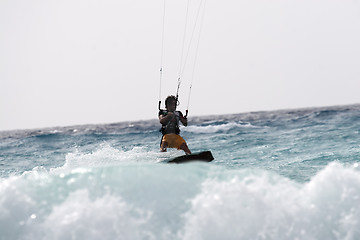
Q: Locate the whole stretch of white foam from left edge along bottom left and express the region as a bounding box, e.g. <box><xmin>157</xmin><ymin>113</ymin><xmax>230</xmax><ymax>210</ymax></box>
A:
<box><xmin>0</xmin><ymin>181</ymin><xmax>154</xmax><ymax>240</ymax></box>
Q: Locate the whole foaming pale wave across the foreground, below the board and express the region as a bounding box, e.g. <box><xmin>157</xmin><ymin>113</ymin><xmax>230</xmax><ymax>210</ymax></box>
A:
<box><xmin>0</xmin><ymin>163</ymin><xmax>360</xmax><ymax>240</ymax></box>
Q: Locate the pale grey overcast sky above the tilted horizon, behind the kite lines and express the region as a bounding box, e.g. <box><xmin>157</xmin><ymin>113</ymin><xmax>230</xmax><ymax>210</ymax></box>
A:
<box><xmin>0</xmin><ymin>0</ymin><xmax>360</xmax><ymax>130</ymax></box>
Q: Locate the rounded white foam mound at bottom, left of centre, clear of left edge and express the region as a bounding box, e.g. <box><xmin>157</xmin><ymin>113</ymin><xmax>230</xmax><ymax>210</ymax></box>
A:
<box><xmin>40</xmin><ymin>190</ymin><xmax>153</xmax><ymax>240</ymax></box>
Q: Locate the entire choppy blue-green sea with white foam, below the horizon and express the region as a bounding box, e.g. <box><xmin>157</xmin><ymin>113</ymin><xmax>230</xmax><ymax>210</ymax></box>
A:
<box><xmin>0</xmin><ymin>105</ymin><xmax>360</xmax><ymax>240</ymax></box>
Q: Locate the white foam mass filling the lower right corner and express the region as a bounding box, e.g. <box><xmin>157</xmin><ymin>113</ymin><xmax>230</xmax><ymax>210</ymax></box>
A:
<box><xmin>181</xmin><ymin>163</ymin><xmax>360</xmax><ymax>240</ymax></box>
